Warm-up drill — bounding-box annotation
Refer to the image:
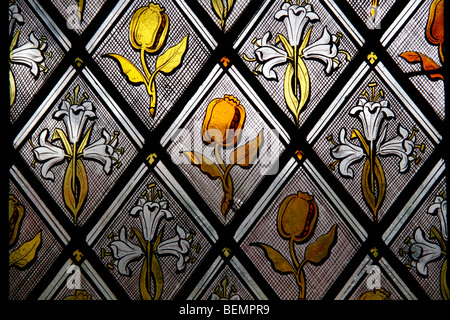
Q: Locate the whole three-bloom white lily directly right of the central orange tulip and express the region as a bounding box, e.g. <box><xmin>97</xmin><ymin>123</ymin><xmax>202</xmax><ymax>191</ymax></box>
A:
<box><xmin>327</xmin><ymin>83</ymin><xmax>425</xmax><ymax>219</ymax></box>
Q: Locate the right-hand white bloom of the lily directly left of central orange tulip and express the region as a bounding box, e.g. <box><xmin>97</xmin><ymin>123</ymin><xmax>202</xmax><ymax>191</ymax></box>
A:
<box><xmin>83</xmin><ymin>129</ymin><xmax>119</xmax><ymax>174</ymax></box>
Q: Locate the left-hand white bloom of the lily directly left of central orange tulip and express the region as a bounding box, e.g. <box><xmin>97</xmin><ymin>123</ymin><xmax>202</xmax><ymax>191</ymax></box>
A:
<box><xmin>33</xmin><ymin>129</ymin><xmax>66</xmax><ymax>180</ymax></box>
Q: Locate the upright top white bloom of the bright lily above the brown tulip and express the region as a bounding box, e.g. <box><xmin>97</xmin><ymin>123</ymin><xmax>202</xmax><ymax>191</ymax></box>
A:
<box><xmin>275</xmin><ymin>3</ymin><xmax>320</xmax><ymax>46</ymax></box>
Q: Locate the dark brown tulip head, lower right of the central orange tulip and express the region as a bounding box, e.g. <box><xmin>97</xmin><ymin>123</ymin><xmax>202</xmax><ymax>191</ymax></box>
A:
<box><xmin>277</xmin><ymin>192</ymin><xmax>318</xmax><ymax>242</ymax></box>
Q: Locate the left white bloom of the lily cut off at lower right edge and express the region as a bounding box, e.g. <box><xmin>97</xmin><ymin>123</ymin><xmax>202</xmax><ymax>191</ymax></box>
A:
<box><xmin>410</xmin><ymin>228</ymin><xmax>442</xmax><ymax>276</ymax></box>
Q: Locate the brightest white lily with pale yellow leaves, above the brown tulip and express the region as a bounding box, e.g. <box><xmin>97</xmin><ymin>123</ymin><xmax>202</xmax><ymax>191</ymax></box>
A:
<box><xmin>243</xmin><ymin>1</ymin><xmax>350</xmax><ymax>124</ymax></box>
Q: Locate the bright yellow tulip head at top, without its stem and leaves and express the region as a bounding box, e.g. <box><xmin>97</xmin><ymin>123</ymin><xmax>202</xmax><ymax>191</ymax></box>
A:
<box><xmin>130</xmin><ymin>3</ymin><xmax>169</xmax><ymax>53</ymax></box>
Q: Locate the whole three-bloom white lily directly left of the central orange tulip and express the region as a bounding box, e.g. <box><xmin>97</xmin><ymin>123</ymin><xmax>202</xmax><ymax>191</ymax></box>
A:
<box><xmin>29</xmin><ymin>85</ymin><xmax>124</xmax><ymax>223</ymax></box>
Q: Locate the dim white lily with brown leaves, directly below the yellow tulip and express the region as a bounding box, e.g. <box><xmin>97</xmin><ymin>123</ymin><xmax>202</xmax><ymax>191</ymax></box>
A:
<box><xmin>105</xmin><ymin>183</ymin><xmax>200</xmax><ymax>300</ymax></box>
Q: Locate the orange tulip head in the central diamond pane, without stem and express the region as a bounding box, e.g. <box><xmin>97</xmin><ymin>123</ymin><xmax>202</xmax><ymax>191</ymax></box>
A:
<box><xmin>202</xmin><ymin>95</ymin><xmax>245</xmax><ymax>146</ymax></box>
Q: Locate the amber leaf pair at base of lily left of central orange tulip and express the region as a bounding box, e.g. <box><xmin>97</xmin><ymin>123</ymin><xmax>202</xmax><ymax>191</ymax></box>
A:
<box><xmin>63</xmin><ymin>157</ymin><xmax>88</xmax><ymax>222</ymax></box>
